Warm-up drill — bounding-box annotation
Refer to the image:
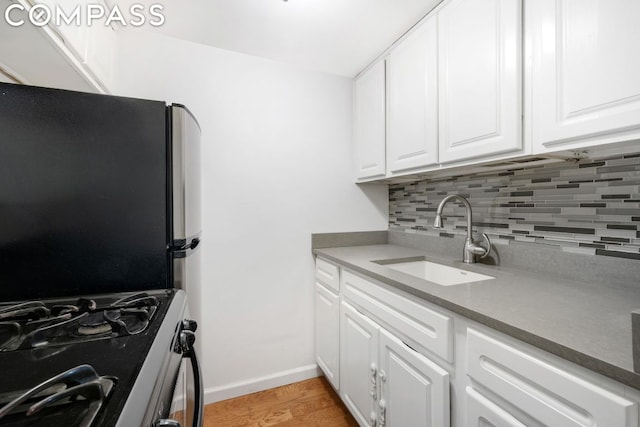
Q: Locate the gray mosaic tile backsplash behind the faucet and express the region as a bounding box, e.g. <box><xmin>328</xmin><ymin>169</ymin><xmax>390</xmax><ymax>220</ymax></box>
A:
<box><xmin>389</xmin><ymin>154</ymin><xmax>640</xmax><ymax>260</ymax></box>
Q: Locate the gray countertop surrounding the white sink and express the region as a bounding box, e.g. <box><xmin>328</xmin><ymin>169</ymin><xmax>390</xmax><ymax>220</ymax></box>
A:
<box><xmin>314</xmin><ymin>244</ymin><xmax>640</xmax><ymax>389</ymax></box>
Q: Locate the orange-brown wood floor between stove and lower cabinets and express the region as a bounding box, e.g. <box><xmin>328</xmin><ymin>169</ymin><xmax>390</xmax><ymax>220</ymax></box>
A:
<box><xmin>204</xmin><ymin>377</ymin><xmax>358</xmax><ymax>427</ymax></box>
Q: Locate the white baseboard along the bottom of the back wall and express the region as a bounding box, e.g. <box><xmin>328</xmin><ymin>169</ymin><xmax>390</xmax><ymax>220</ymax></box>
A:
<box><xmin>204</xmin><ymin>363</ymin><xmax>322</xmax><ymax>404</ymax></box>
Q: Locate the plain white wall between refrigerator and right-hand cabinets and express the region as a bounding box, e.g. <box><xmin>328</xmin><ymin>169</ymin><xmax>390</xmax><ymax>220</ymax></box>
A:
<box><xmin>114</xmin><ymin>30</ymin><xmax>388</xmax><ymax>402</ymax></box>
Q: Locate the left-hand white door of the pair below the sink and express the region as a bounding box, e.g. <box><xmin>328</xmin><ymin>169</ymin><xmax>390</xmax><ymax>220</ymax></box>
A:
<box><xmin>340</xmin><ymin>301</ymin><xmax>378</xmax><ymax>426</ymax></box>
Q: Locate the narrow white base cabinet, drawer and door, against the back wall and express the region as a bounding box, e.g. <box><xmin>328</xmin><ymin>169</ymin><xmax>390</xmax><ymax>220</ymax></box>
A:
<box><xmin>315</xmin><ymin>258</ymin><xmax>340</xmax><ymax>390</ymax></box>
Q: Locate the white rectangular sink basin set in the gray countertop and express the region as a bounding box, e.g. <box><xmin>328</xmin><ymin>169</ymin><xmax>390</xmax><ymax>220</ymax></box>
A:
<box><xmin>378</xmin><ymin>260</ymin><xmax>495</xmax><ymax>286</ymax></box>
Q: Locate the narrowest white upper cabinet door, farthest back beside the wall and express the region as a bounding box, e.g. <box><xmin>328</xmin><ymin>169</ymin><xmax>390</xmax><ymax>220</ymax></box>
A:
<box><xmin>354</xmin><ymin>61</ymin><xmax>386</xmax><ymax>179</ymax></box>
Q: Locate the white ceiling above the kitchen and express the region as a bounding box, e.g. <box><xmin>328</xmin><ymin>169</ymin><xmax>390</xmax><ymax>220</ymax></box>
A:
<box><xmin>109</xmin><ymin>0</ymin><xmax>440</xmax><ymax>77</ymax></box>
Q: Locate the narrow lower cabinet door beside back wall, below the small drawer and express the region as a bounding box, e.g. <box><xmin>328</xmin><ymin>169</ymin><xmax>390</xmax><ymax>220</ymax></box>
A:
<box><xmin>316</xmin><ymin>283</ymin><xmax>340</xmax><ymax>390</ymax></box>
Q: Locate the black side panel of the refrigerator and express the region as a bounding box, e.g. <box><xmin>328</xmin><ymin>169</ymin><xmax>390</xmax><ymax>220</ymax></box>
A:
<box><xmin>0</xmin><ymin>84</ymin><xmax>170</xmax><ymax>300</ymax></box>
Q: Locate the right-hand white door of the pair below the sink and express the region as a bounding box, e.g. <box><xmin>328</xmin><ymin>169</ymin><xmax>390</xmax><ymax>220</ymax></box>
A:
<box><xmin>378</xmin><ymin>329</ymin><xmax>450</xmax><ymax>427</ymax></box>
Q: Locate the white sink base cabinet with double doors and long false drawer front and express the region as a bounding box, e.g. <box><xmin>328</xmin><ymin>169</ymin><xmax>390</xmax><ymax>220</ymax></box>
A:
<box><xmin>340</xmin><ymin>270</ymin><xmax>452</xmax><ymax>427</ymax></box>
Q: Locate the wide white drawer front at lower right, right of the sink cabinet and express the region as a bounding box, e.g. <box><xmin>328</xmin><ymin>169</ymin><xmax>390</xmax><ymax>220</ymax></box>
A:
<box><xmin>467</xmin><ymin>328</ymin><xmax>638</xmax><ymax>427</ymax></box>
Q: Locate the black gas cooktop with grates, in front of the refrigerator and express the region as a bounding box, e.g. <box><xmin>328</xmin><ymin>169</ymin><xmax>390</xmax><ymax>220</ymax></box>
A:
<box><xmin>0</xmin><ymin>290</ymin><xmax>175</xmax><ymax>427</ymax></box>
